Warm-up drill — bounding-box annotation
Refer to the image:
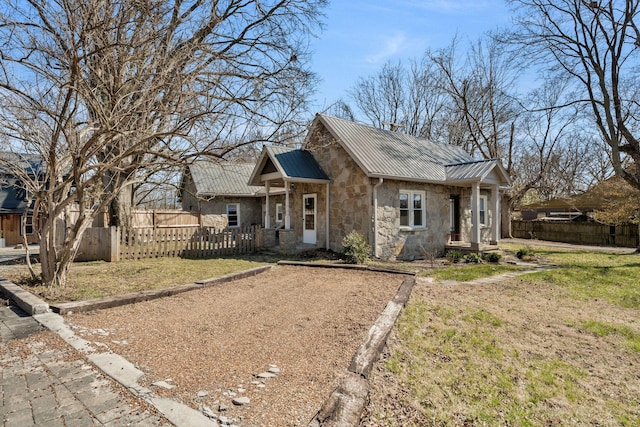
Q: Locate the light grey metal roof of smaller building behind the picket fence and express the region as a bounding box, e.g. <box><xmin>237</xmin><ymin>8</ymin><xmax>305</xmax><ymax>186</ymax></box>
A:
<box><xmin>189</xmin><ymin>160</ymin><xmax>262</xmax><ymax>196</ymax></box>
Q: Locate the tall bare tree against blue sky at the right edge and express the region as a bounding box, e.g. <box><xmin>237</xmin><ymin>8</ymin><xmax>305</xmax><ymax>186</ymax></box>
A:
<box><xmin>504</xmin><ymin>0</ymin><xmax>640</xmax><ymax>246</ymax></box>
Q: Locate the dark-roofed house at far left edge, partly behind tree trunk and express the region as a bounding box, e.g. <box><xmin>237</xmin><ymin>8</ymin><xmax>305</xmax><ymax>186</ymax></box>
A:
<box><xmin>0</xmin><ymin>152</ymin><xmax>44</xmax><ymax>246</ymax></box>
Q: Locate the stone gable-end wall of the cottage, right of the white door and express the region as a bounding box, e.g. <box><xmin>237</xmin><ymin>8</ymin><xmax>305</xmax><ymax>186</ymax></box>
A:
<box><xmin>308</xmin><ymin>125</ymin><xmax>373</xmax><ymax>252</ymax></box>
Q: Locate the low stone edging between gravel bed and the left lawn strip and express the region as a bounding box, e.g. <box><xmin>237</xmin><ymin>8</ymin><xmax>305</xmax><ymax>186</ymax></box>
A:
<box><xmin>51</xmin><ymin>265</ymin><xmax>271</xmax><ymax>314</ymax></box>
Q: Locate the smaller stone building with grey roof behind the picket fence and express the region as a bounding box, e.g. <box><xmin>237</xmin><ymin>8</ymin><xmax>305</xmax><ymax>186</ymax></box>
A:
<box><xmin>180</xmin><ymin>160</ymin><xmax>284</xmax><ymax>228</ymax></box>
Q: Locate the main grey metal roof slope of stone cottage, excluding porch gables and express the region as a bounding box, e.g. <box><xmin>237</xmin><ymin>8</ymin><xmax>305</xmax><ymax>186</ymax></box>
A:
<box><xmin>316</xmin><ymin>114</ymin><xmax>474</xmax><ymax>182</ymax></box>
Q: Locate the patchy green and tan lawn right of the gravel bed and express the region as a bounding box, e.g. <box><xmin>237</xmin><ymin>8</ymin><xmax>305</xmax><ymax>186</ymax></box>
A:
<box><xmin>362</xmin><ymin>248</ymin><xmax>640</xmax><ymax>426</ymax></box>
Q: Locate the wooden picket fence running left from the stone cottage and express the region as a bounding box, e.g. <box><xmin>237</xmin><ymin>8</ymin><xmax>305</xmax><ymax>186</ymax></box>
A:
<box><xmin>119</xmin><ymin>225</ymin><xmax>260</xmax><ymax>259</ymax></box>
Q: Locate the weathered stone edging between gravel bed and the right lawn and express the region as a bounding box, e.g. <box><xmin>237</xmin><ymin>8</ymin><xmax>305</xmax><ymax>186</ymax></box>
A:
<box><xmin>309</xmin><ymin>275</ymin><xmax>416</xmax><ymax>427</ymax></box>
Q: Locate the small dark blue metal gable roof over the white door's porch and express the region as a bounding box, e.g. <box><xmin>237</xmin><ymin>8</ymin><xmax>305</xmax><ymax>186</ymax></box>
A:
<box><xmin>248</xmin><ymin>146</ymin><xmax>330</xmax><ymax>185</ymax></box>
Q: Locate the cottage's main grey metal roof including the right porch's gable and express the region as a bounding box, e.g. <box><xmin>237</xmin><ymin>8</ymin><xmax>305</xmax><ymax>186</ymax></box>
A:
<box><xmin>305</xmin><ymin>114</ymin><xmax>510</xmax><ymax>184</ymax></box>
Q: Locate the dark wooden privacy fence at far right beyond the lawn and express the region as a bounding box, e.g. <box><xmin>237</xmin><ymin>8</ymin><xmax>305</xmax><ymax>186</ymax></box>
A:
<box><xmin>511</xmin><ymin>220</ymin><xmax>638</xmax><ymax>248</ymax></box>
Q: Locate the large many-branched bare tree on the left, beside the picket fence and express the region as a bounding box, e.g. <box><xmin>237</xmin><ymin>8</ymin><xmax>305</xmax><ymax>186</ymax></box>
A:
<box><xmin>0</xmin><ymin>0</ymin><xmax>326</xmax><ymax>285</ymax></box>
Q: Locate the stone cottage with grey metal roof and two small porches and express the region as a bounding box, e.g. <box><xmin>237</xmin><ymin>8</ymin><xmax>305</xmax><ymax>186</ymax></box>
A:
<box><xmin>248</xmin><ymin>114</ymin><xmax>510</xmax><ymax>259</ymax></box>
